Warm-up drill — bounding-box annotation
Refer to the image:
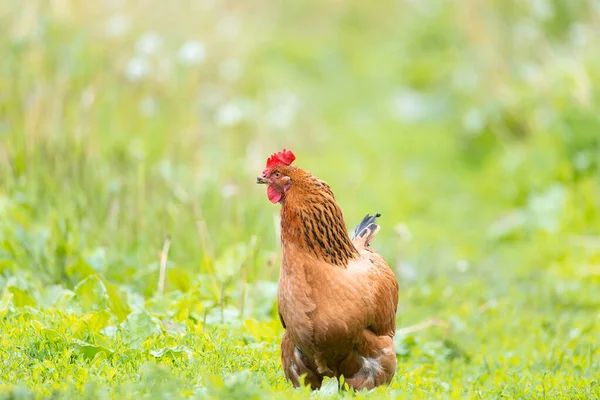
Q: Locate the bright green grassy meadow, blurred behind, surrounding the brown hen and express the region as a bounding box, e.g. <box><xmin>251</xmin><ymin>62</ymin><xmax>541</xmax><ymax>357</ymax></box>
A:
<box><xmin>0</xmin><ymin>0</ymin><xmax>600</xmax><ymax>399</ymax></box>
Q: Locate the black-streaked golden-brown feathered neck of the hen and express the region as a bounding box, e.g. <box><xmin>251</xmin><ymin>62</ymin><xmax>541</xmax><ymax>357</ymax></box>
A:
<box><xmin>281</xmin><ymin>173</ymin><xmax>358</xmax><ymax>267</ymax></box>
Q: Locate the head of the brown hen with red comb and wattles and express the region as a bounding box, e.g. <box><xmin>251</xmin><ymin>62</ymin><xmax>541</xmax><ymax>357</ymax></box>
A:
<box><xmin>256</xmin><ymin>149</ymin><xmax>299</xmax><ymax>204</ymax></box>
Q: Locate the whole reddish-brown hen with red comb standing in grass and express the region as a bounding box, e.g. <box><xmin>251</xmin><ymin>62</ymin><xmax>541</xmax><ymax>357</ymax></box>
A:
<box><xmin>257</xmin><ymin>149</ymin><xmax>398</xmax><ymax>390</ymax></box>
